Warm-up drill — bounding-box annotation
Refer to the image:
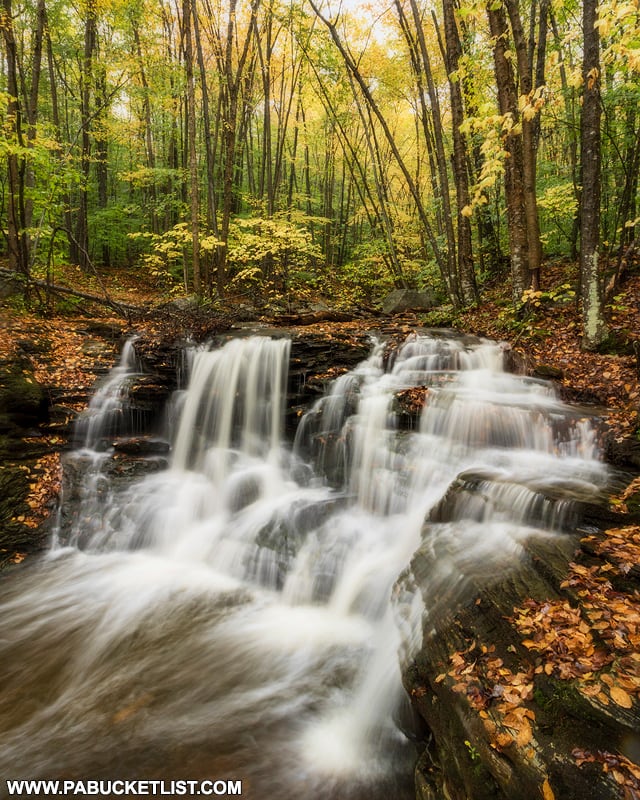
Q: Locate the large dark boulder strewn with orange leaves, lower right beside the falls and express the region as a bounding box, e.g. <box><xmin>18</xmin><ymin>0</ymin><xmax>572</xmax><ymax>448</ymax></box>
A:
<box><xmin>395</xmin><ymin>512</ymin><xmax>640</xmax><ymax>800</ymax></box>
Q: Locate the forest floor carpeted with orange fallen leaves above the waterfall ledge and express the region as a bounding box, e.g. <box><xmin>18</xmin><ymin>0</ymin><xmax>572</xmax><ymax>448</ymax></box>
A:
<box><xmin>6</xmin><ymin>262</ymin><xmax>640</xmax><ymax>436</ymax></box>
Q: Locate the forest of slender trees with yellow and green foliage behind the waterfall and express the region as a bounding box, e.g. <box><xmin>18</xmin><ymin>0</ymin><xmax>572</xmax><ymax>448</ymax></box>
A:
<box><xmin>1</xmin><ymin>0</ymin><xmax>640</xmax><ymax>350</ymax></box>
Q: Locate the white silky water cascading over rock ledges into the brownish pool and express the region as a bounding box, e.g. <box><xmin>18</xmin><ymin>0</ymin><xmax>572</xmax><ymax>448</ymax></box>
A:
<box><xmin>0</xmin><ymin>336</ymin><xmax>606</xmax><ymax>800</ymax></box>
